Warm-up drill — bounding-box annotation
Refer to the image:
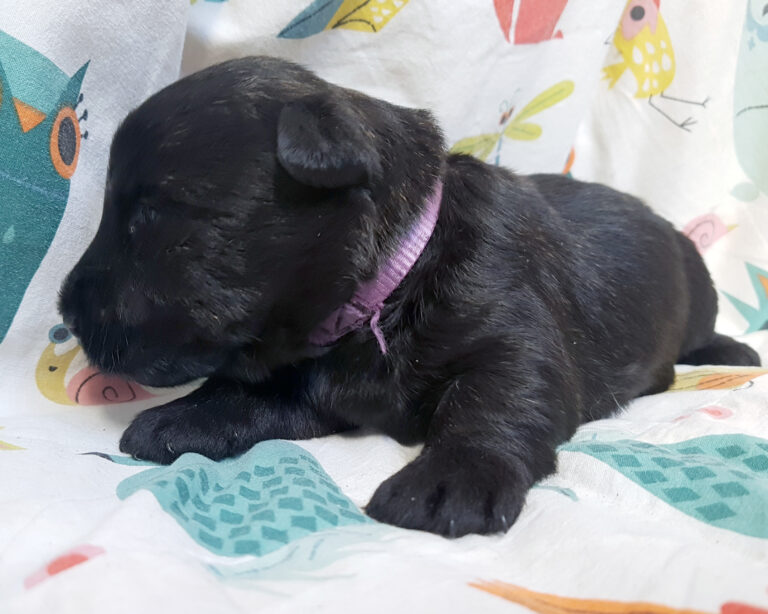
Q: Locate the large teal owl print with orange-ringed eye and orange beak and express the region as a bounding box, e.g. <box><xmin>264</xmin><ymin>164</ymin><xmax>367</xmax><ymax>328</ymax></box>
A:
<box><xmin>0</xmin><ymin>31</ymin><xmax>88</xmax><ymax>341</ymax></box>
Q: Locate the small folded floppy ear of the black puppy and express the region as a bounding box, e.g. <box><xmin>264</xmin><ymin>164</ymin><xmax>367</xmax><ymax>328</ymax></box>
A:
<box><xmin>277</xmin><ymin>94</ymin><xmax>381</xmax><ymax>188</ymax></box>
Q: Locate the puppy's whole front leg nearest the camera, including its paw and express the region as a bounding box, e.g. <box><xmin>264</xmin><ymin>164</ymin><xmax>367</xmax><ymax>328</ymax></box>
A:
<box><xmin>367</xmin><ymin>354</ymin><xmax>578</xmax><ymax>537</ymax></box>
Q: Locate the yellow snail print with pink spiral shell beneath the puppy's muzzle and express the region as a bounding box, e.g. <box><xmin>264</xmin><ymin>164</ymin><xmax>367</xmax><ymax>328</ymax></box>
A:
<box><xmin>35</xmin><ymin>324</ymin><xmax>156</xmax><ymax>405</ymax></box>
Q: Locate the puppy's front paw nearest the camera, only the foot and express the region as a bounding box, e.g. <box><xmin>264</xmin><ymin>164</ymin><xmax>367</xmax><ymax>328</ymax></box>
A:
<box><xmin>366</xmin><ymin>449</ymin><xmax>530</xmax><ymax>537</ymax></box>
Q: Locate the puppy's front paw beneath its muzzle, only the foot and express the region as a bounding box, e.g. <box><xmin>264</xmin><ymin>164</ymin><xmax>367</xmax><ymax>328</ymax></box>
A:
<box><xmin>120</xmin><ymin>398</ymin><xmax>248</xmax><ymax>464</ymax></box>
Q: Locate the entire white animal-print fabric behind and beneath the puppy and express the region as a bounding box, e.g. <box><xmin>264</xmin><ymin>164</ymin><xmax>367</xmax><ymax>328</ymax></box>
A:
<box><xmin>0</xmin><ymin>0</ymin><xmax>768</xmax><ymax>614</ymax></box>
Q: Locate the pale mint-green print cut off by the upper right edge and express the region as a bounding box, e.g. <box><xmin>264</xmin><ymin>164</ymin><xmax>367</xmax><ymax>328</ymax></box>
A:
<box><xmin>733</xmin><ymin>0</ymin><xmax>768</xmax><ymax>196</ymax></box>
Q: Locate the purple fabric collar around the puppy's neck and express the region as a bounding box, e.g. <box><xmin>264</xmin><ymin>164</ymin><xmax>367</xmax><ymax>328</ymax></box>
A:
<box><xmin>309</xmin><ymin>181</ymin><xmax>443</xmax><ymax>354</ymax></box>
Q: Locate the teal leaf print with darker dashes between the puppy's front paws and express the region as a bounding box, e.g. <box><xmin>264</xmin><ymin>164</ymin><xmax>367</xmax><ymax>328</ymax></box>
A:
<box><xmin>112</xmin><ymin>440</ymin><xmax>373</xmax><ymax>557</ymax></box>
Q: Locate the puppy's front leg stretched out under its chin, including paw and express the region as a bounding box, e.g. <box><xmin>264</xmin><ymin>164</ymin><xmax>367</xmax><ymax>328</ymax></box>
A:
<box><xmin>120</xmin><ymin>379</ymin><xmax>349</xmax><ymax>463</ymax></box>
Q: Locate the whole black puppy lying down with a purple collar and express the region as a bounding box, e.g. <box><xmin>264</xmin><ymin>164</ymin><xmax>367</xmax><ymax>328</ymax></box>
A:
<box><xmin>60</xmin><ymin>57</ymin><xmax>759</xmax><ymax>536</ymax></box>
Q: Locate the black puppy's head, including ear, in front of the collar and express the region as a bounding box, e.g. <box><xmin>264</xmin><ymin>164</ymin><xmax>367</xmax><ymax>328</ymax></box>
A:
<box><xmin>60</xmin><ymin>57</ymin><xmax>442</xmax><ymax>386</ymax></box>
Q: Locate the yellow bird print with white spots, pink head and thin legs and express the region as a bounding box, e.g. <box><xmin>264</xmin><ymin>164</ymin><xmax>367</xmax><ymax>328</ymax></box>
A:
<box><xmin>603</xmin><ymin>0</ymin><xmax>709</xmax><ymax>131</ymax></box>
